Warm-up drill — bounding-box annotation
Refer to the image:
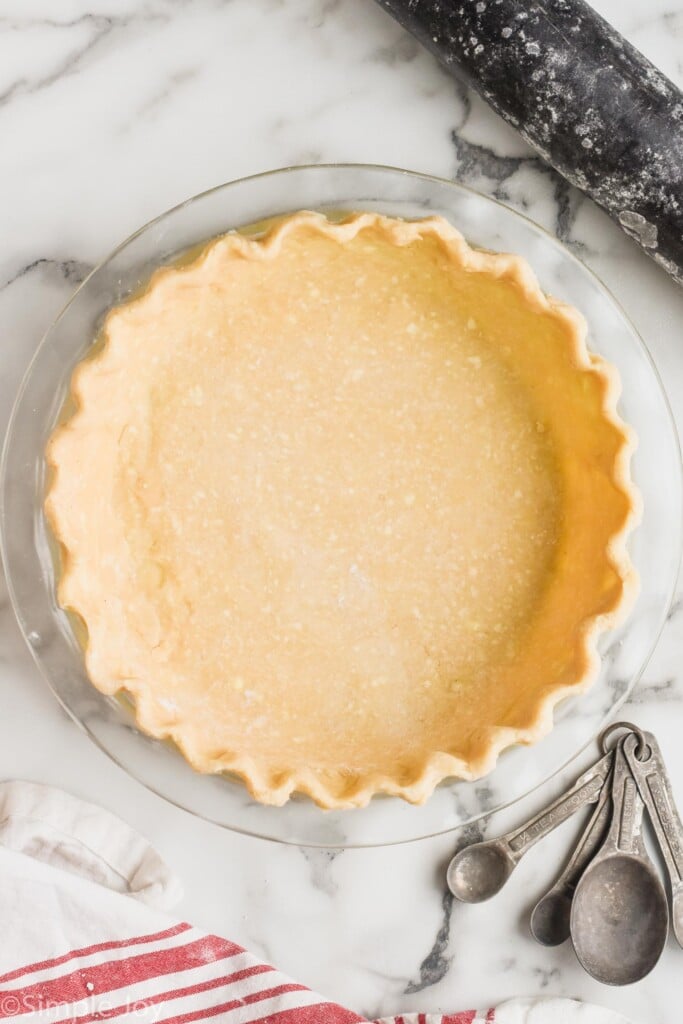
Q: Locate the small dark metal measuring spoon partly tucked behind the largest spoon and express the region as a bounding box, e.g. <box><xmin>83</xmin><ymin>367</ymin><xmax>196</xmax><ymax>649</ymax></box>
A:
<box><xmin>531</xmin><ymin>778</ymin><xmax>611</xmax><ymax>946</ymax></box>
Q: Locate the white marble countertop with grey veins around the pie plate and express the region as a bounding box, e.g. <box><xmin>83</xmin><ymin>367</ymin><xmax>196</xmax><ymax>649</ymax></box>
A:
<box><xmin>0</xmin><ymin>0</ymin><xmax>683</xmax><ymax>1024</ymax></box>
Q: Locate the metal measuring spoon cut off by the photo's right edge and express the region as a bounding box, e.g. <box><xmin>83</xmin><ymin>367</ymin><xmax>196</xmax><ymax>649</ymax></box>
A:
<box><xmin>624</xmin><ymin>732</ymin><xmax>683</xmax><ymax>946</ymax></box>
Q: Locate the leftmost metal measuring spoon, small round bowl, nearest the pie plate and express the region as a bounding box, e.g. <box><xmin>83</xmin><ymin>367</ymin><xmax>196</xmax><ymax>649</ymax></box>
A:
<box><xmin>446</xmin><ymin>751</ymin><xmax>613</xmax><ymax>903</ymax></box>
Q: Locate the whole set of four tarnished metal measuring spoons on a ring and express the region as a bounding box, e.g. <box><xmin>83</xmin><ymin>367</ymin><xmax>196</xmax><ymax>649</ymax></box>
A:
<box><xmin>447</xmin><ymin>722</ymin><xmax>683</xmax><ymax>985</ymax></box>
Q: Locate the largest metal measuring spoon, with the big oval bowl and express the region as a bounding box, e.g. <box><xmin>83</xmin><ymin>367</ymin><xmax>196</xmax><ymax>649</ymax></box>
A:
<box><xmin>570</xmin><ymin>740</ymin><xmax>669</xmax><ymax>985</ymax></box>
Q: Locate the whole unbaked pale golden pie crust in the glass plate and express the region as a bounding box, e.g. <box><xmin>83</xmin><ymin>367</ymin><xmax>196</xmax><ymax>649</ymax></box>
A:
<box><xmin>46</xmin><ymin>212</ymin><xmax>637</xmax><ymax>807</ymax></box>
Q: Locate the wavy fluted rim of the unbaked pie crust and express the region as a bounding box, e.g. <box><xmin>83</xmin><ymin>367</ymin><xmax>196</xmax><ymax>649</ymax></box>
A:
<box><xmin>45</xmin><ymin>212</ymin><xmax>639</xmax><ymax>808</ymax></box>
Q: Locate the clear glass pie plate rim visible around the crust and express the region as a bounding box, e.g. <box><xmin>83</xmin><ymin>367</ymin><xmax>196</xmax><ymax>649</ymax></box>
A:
<box><xmin>2</xmin><ymin>165</ymin><xmax>682</xmax><ymax>847</ymax></box>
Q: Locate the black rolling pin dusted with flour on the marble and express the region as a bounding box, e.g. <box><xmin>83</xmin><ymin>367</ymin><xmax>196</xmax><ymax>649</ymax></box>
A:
<box><xmin>378</xmin><ymin>0</ymin><xmax>683</xmax><ymax>284</ymax></box>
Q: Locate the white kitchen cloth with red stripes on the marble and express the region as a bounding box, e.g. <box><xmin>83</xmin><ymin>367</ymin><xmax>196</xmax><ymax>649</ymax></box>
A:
<box><xmin>0</xmin><ymin>782</ymin><xmax>628</xmax><ymax>1024</ymax></box>
